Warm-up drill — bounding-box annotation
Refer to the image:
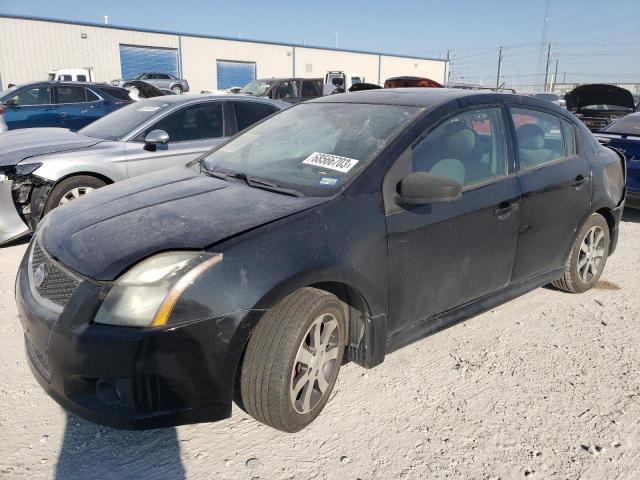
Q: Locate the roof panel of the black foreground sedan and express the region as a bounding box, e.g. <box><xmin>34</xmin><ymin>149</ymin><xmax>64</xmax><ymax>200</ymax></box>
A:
<box><xmin>306</xmin><ymin>87</ymin><xmax>558</xmax><ymax>111</ymax></box>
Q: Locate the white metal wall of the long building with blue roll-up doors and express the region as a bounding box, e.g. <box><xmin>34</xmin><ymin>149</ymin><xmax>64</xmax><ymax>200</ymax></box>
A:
<box><xmin>0</xmin><ymin>17</ymin><xmax>445</xmax><ymax>93</ymax></box>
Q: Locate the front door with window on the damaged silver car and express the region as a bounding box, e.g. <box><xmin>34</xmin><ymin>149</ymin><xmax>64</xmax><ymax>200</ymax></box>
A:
<box><xmin>126</xmin><ymin>100</ymin><xmax>228</xmax><ymax>177</ymax></box>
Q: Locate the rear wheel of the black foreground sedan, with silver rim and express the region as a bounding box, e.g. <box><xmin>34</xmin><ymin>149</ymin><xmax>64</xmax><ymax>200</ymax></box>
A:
<box><xmin>552</xmin><ymin>213</ymin><xmax>609</xmax><ymax>293</ymax></box>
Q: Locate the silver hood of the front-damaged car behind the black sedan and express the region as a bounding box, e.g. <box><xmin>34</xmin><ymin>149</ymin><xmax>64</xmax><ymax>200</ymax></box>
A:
<box><xmin>0</xmin><ymin>128</ymin><xmax>101</xmax><ymax>167</ymax></box>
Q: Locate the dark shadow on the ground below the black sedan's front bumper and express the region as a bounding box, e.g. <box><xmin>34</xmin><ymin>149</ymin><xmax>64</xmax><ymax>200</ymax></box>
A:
<box><xmin>53</xmin><ymin>414</ymin><xmax>186</xmax><ymax>480</ymax></box>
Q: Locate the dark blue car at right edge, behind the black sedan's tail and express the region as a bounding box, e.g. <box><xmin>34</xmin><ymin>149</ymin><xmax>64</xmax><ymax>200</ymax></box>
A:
<box><xmin>596</xmin><ymin>112</ymin><xmax>640</xmax><ymax>208</ymax></box>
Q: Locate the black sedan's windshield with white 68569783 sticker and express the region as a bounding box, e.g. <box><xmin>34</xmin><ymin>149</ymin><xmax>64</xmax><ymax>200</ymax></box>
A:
<box><xmin>203</xmin><ymin>103</ymin><xmax>422</xmax><ymax>196</ymax></box>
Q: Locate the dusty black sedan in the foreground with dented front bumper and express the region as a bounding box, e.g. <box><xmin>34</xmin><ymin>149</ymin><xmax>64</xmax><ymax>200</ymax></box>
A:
<box><xmin>17</xmin><ymin>89</ymin><xmax>625</xmax><ymax>432</ymax></box>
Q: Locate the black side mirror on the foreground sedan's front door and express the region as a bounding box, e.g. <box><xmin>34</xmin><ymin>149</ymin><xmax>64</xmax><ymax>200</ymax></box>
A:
<box><xmin>398</xmin><ymin>172</ymin><xmax>462</xmax><ymax>205</ymax></box>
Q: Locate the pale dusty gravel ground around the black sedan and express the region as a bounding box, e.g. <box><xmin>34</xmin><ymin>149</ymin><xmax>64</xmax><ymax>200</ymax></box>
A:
<box><xmin>0</xmin><ymin>211</ymin><xmax>640</xmax><ymax>480</ymax></box>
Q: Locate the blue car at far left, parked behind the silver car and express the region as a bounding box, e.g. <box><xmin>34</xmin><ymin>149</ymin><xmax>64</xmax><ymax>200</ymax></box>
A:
<box><xmin>0</xmin><ymin>81</ymin><xmax>133</xmax><ymax>130</ymax></box>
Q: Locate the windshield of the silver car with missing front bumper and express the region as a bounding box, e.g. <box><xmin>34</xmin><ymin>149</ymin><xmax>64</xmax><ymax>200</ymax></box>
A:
<box><xmin>78</xmin><ymin>97</ymin><xmax>171</xmax><ymax>140</ymax></box>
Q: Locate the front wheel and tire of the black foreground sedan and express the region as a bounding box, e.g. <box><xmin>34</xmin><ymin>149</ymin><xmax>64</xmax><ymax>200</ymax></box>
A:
<box><xmin>240</xmin><ymin>288</ymin><xmax>347</xmax><ymax>432</ymax></box>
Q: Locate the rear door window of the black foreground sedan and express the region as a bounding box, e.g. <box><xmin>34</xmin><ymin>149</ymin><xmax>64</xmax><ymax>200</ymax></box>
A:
<box><xmin>511</xmin><ymin>108</ymin><xmax>564</xmax><ymax>170</ymax></box>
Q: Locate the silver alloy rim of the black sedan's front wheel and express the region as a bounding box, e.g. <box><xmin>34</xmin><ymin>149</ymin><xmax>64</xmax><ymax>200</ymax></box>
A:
<box><xmin>290</xmin><ymin>314</ymin><xmax>341</xmax><ymax>414</ymax></box>
